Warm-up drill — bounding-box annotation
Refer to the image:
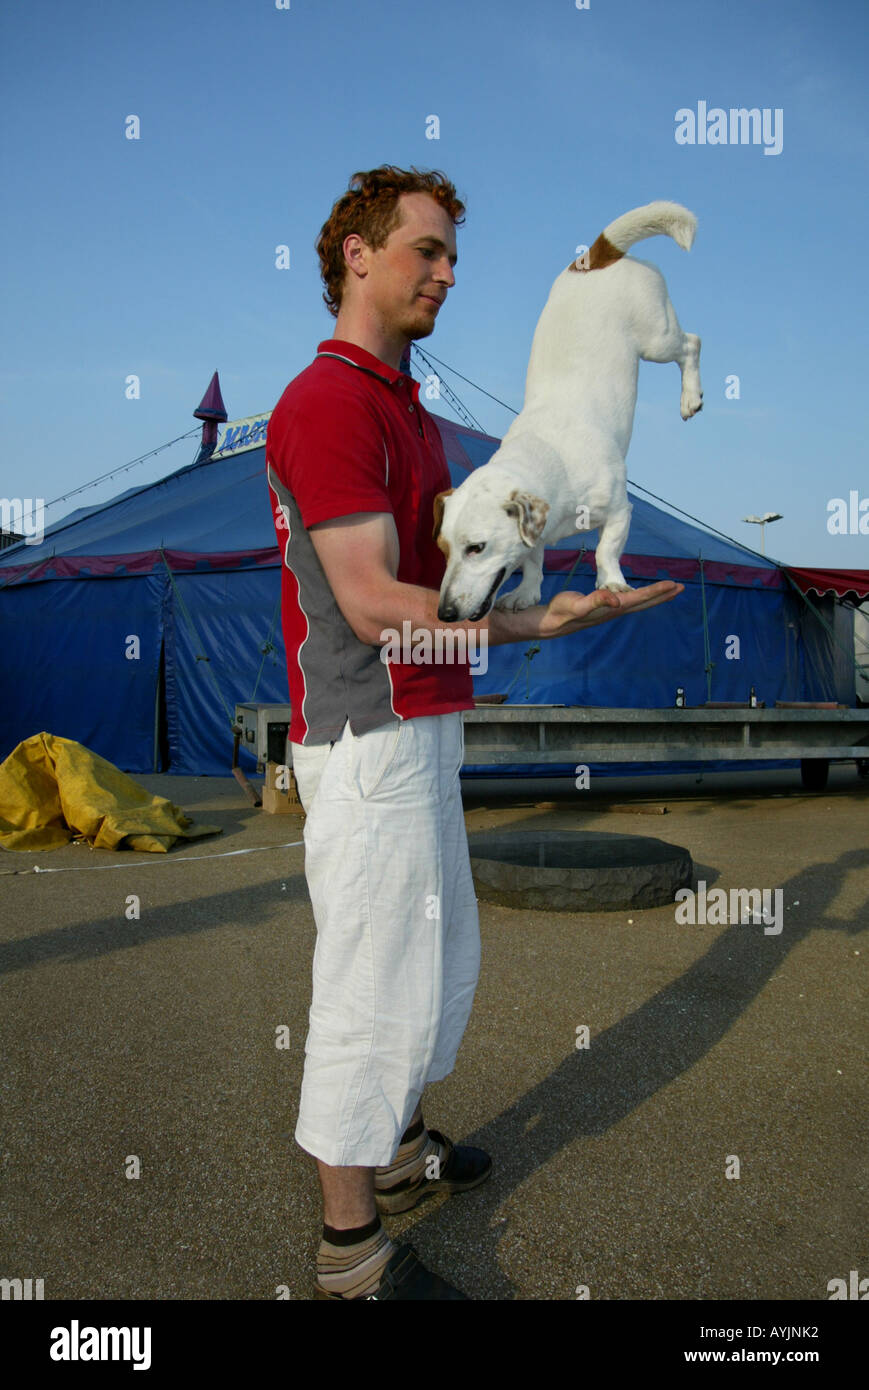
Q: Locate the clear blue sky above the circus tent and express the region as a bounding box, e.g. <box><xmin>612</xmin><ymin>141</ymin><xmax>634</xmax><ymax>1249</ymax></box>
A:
<box><xmin>0</xmin><ymin>0</ymin><xmax>869</xmax><ymax>569</ymax></box>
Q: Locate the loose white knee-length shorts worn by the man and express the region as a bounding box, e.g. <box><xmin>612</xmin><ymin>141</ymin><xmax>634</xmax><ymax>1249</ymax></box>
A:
<box><xmin>291</xmin><ymin>710</ymin><xmax>480</xmax><ymax>1168</ymax></box>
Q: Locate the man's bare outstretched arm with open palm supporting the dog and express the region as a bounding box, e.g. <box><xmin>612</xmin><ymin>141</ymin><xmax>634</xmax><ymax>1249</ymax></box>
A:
<box><xmin>310</xmin><ymin>512</ymin><xmax>684</xmax><ymax>646</ymax></box>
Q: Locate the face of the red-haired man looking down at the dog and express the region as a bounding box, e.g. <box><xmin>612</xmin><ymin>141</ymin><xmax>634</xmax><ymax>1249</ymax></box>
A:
<box><xmin>345</xmin><ymin>193</ymin><xmax>457</xmax><ymax>341</ymax></box>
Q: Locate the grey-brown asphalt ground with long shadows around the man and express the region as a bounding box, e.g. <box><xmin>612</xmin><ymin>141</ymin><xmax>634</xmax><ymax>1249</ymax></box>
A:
<box><xmin>0</xmin><ymin>763</ymin><xmax>869</xmax><ymax>1300</ymax></box>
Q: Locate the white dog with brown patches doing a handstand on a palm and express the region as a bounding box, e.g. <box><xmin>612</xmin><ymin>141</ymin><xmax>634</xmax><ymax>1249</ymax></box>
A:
<box><xmin>434</xmin><ymin>202</ymin><xmax>704</xmax><ymax>623</ymax></box>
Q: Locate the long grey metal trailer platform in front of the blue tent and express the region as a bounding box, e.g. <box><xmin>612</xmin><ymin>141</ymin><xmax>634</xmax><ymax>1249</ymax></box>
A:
<box><xmin>462</xmin><ymin>705</ymin><xmax>869</xmax><ymax>791</ymax></box>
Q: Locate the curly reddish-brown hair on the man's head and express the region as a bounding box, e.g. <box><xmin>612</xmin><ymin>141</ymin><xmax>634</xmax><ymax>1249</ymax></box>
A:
<box><xmin>317</xmin><ymin>164</ymin><xmax>464</xmax><ymax>318</ymax></box>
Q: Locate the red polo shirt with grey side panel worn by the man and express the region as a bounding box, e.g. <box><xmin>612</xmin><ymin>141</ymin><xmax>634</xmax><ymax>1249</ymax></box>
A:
<box><xmin>266</xmin><ymin>338</ymin><xmax>474</xmax><ymax>744</ymax></box>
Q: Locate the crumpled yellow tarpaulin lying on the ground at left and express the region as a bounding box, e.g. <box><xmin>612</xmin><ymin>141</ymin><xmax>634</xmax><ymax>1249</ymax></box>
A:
<box><xmin>0</xmin><ymin>734</ymin><xmax>221</xmax><ymax>853</ymax></box>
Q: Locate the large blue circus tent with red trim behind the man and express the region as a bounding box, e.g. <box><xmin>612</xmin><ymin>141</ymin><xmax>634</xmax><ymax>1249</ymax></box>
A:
<box><xmin>0</xmin><ymin>414</ymin><xmax>855</xmax><ymax>776</ymax></box>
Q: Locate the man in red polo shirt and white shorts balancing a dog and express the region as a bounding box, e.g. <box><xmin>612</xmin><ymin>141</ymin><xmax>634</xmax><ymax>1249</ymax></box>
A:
<box><xmin>266</xmin><ymin>165</ymin><xmax>683</xmax><ymax>1300</ymax></box>
